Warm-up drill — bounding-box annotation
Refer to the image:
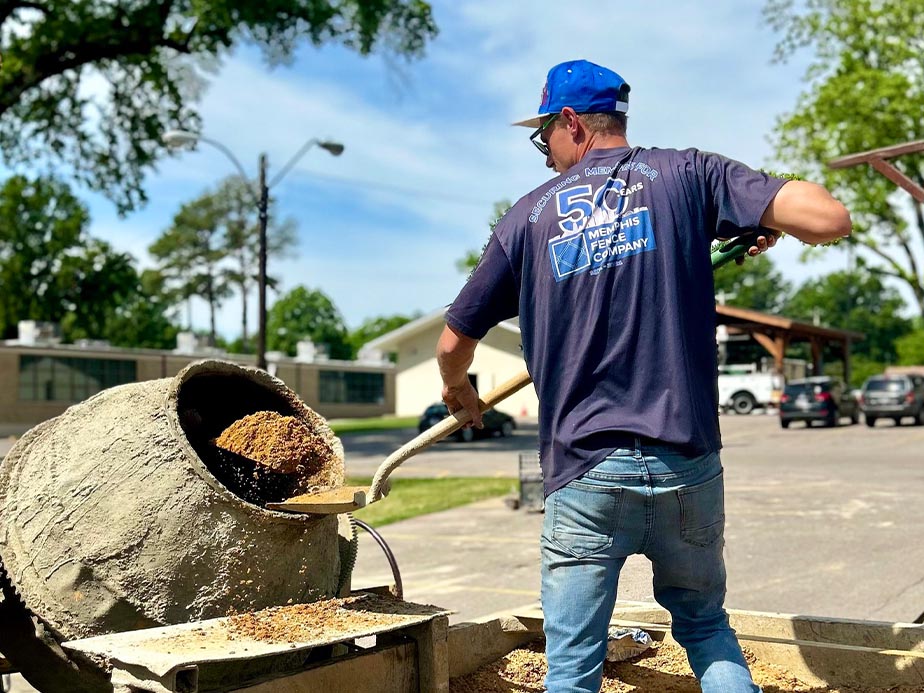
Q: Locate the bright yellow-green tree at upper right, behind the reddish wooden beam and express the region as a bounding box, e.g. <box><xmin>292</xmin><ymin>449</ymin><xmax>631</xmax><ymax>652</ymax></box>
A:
<box><xmin>764</xmin><ymin>0</ymin><xmax>924</xmax><ymax>315</ymax></box>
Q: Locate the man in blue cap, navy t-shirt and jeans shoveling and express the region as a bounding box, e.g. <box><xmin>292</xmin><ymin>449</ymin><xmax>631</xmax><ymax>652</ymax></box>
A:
<box><xmin>437</xmin><ymin>60</ymin><xmax>850</xmax><ymax>693</ymax></box>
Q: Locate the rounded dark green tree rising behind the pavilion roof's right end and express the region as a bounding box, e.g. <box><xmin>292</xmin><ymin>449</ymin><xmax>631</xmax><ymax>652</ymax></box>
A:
<box><xmin>785</xmin><ymin>270</ymin><xmax>911</xmax><ymax>363</ymax></box>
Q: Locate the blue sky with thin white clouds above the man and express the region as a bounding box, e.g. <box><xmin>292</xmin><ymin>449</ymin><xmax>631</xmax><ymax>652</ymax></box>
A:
<box><xmin>72</xmin><ymin>0</ymin><xmax>846</xmax><ymax>337</ymax></box>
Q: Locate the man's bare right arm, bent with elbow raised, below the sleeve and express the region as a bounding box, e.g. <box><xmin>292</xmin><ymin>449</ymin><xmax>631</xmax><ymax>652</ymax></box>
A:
<box><xmin>760</xmin><ymin>180</ymin><xmax>851</xmax><ymax>245</ymax></box>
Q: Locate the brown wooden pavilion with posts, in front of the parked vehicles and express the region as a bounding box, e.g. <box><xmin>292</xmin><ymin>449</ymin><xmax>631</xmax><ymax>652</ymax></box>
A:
<box><xmin>715</xmin><ymin>305</ymin><xmax>866</xmax><ymax>382</ymax></box>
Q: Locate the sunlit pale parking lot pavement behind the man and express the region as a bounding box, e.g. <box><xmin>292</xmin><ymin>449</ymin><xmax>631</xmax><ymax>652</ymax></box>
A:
<box><xmin>0</xmin><ymin>416</ymin><xmax>924</xmax><ymax>693</ymax></box>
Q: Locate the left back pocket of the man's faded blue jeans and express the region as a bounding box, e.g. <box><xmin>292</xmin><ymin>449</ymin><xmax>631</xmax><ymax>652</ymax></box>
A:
<box><xmin>546</xmin><ymin>481</ymin><xmax>622</xmax><ymax>558</ymax></box>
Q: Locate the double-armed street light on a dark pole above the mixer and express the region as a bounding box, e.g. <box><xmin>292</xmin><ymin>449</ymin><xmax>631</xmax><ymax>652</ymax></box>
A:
<box><xmin>163</xmin><ymin>130</ymin><xmax>343</xmax><ymax>370</ymax></box>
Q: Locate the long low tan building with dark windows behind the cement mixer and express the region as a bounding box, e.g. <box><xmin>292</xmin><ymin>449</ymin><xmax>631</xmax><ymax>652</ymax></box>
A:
<box><xmin>0</xmin><ymin>328</ymin><xmax>395</xmax><ymax>435</ymax></box>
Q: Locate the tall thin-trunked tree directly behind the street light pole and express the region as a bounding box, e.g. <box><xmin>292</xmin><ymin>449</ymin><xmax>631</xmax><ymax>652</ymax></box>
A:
<box><xmin>213</xmin><ymin>176</ymin><xmax>296</xmax><ymax>353</ymax></box>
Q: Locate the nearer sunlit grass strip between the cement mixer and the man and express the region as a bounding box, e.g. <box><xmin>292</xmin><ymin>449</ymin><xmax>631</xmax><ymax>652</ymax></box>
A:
<box><xmin>346</xmin><ymin>477</ymin><xmax>517</xmax><ymax>527</ymax></box>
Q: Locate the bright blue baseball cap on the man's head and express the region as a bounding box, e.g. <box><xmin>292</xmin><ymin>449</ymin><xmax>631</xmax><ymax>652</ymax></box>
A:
<box><xmin>514</xmin><ymin>60</ymin><xmax>629</xmax><ymax>128</ymax></box>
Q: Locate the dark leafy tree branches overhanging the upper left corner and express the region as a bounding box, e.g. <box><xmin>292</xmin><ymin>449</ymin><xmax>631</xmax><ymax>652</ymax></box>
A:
<box><xmin>0</xmin><ymin>0</ymin><xmax>436</xmax><ymax>212</ymax></box>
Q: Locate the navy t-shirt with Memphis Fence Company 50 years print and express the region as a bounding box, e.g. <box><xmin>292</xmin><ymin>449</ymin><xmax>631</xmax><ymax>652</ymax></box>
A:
<box><xmin>446</xmin><ymin>147</ymin><xmax>785</xmax><ymax>495</ymax></box>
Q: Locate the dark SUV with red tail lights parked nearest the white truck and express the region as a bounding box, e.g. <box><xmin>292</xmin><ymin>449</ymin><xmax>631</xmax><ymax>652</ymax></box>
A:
<box><xmin>780</xmin><ymin>376</ymin><xmax>860</xmax><ymax>428</ymax></box>
